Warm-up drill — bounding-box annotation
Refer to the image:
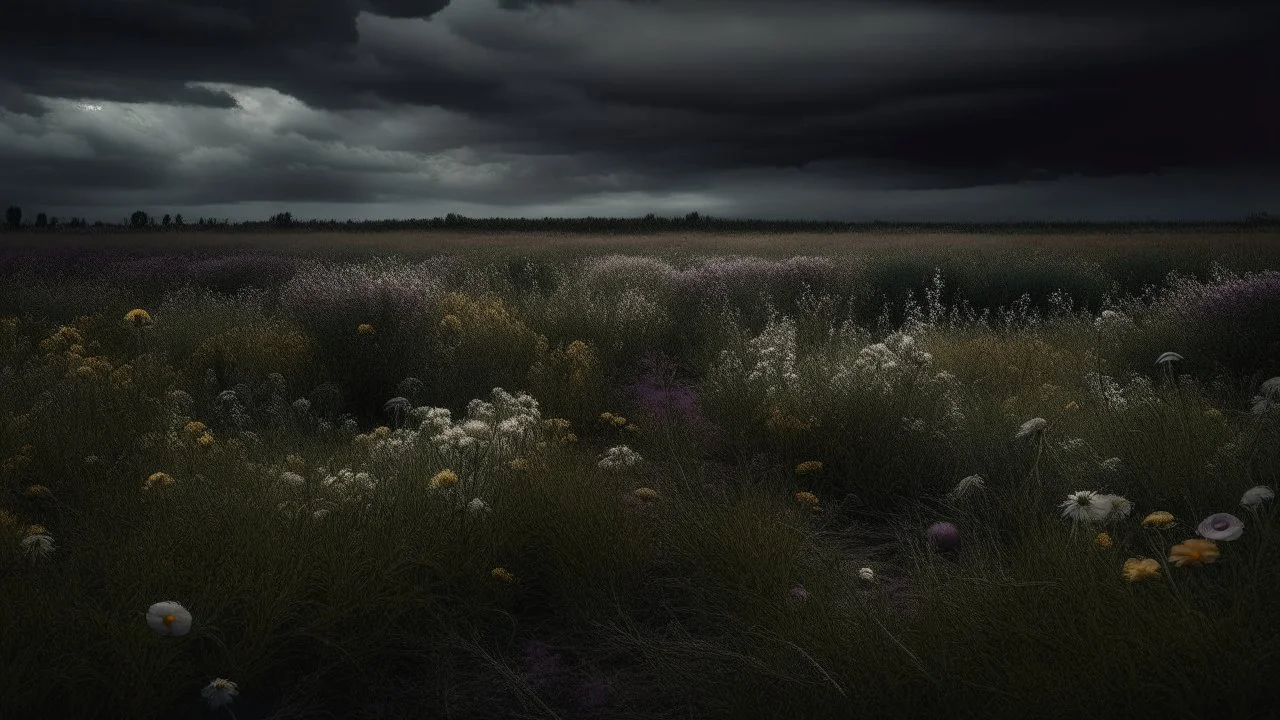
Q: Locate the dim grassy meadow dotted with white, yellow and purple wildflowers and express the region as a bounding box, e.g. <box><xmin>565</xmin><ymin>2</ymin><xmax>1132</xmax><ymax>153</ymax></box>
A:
<box><xmin>0</xmin><ymin>228</ymin><xmax>1280</xmax><ymax>720</ymax></box>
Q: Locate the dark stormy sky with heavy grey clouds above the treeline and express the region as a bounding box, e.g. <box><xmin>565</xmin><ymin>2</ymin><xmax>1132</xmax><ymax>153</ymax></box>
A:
<box><xmin>0</xmin><ymin>0</ymin><xmax>1280</xmax><ymax>222</ymax></box>
